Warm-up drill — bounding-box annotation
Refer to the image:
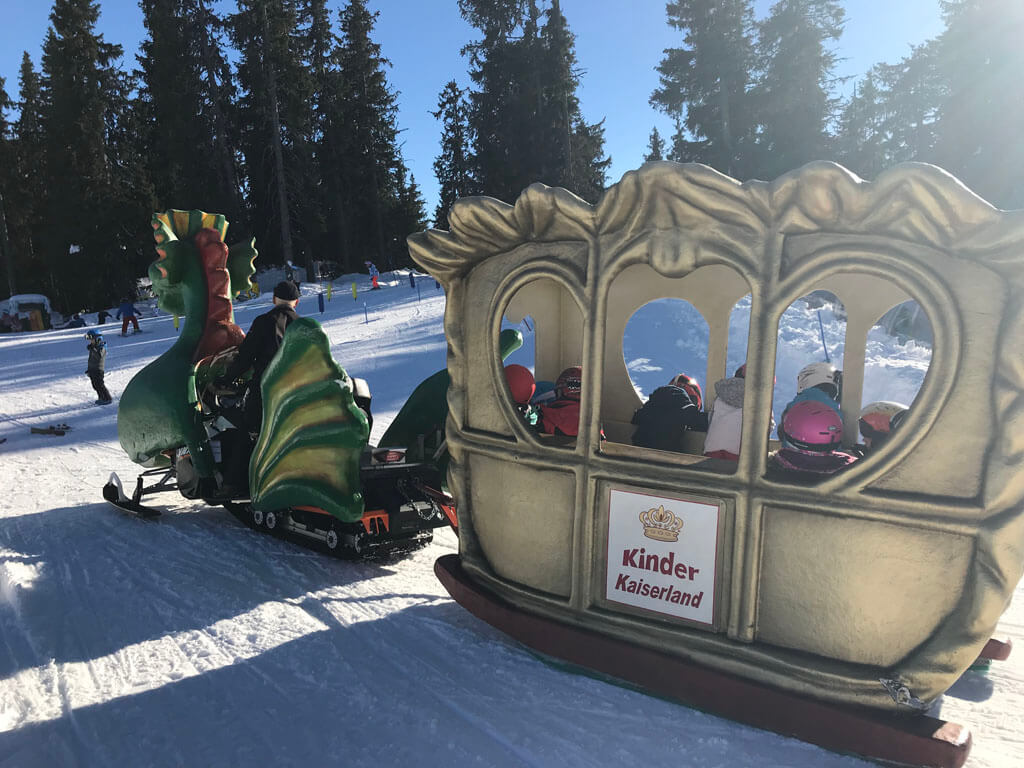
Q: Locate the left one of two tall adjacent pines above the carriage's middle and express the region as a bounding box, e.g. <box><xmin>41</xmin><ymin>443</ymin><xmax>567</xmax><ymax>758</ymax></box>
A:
<box><xmin>650</xmin><ymin>0</ymin><xmax>756</xmax><ymax>178</ymax></box>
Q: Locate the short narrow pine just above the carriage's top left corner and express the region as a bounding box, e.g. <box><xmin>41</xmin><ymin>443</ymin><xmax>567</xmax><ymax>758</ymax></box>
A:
<box><xmin>431</xmin><ymin>80</ymin><xmax>475</xmax><ymax>228</ymax></box>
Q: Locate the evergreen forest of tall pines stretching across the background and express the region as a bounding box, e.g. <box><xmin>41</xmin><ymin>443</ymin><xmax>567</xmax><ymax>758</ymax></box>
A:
<box><xmin>0</xmin><ymin>0</ymin><xmax>1024</xmax><ymax>312</ymax></box>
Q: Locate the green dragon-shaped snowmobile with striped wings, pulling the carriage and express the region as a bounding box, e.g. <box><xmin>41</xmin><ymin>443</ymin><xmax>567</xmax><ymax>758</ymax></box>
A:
<box><xmin>103</xmin><ymin>211</ymin><xmax>457</xmax><ymax>557</ymax></box>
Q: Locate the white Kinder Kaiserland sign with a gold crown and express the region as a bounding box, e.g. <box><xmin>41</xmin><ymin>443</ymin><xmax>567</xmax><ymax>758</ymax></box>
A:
<box><xmin>605</xmin><ymin>489</ymin><xmax>719</xmax><ymax>625</ymax></box>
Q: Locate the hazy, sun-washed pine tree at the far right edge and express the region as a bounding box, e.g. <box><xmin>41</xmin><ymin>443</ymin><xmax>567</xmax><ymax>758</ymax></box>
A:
<box><xmin>936</xmin><ymin>0</ymin><xmax>1024</xmax><ymax>207</ymax></box>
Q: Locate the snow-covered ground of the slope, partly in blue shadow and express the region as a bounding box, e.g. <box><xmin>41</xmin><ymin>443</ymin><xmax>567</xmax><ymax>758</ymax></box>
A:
<box><xmin>0</xmin><ymin>275</ymin><xmax>1024</xmax><ymax>768</ymax></box>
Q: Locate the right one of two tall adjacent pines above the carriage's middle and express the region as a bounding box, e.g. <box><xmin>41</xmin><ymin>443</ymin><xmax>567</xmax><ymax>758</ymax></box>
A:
<box><xmin>753</xmin><ymin>0</ymin><xmax>844</xmax><ymax>178</ymax></box>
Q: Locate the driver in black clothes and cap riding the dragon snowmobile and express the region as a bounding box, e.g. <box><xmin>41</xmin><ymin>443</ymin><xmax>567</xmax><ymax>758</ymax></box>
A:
<box><xmin>217</xmin><ymin>280</ymin><xmax>299</xmax><ymax>432</ymax></box>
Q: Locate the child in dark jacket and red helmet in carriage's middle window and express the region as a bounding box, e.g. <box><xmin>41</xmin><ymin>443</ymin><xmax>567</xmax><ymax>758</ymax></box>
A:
<box><xmin>633</xmin><ymin>374</ymin><xmax>708</xmax><ymax>454</ymax></box>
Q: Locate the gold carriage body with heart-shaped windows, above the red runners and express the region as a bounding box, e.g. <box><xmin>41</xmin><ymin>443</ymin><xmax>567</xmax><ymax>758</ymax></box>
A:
<box><xmin>410</xmin><ymin>157</ymin><xmax>1024</xmax><ymax>745</ymax></box>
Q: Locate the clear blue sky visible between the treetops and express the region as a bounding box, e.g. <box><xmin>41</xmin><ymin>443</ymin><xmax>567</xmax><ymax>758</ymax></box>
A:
<box><xmin>0</xmin><ymin>0</ymin><xmax>942</xmax><ymax>217</ymax></box>
